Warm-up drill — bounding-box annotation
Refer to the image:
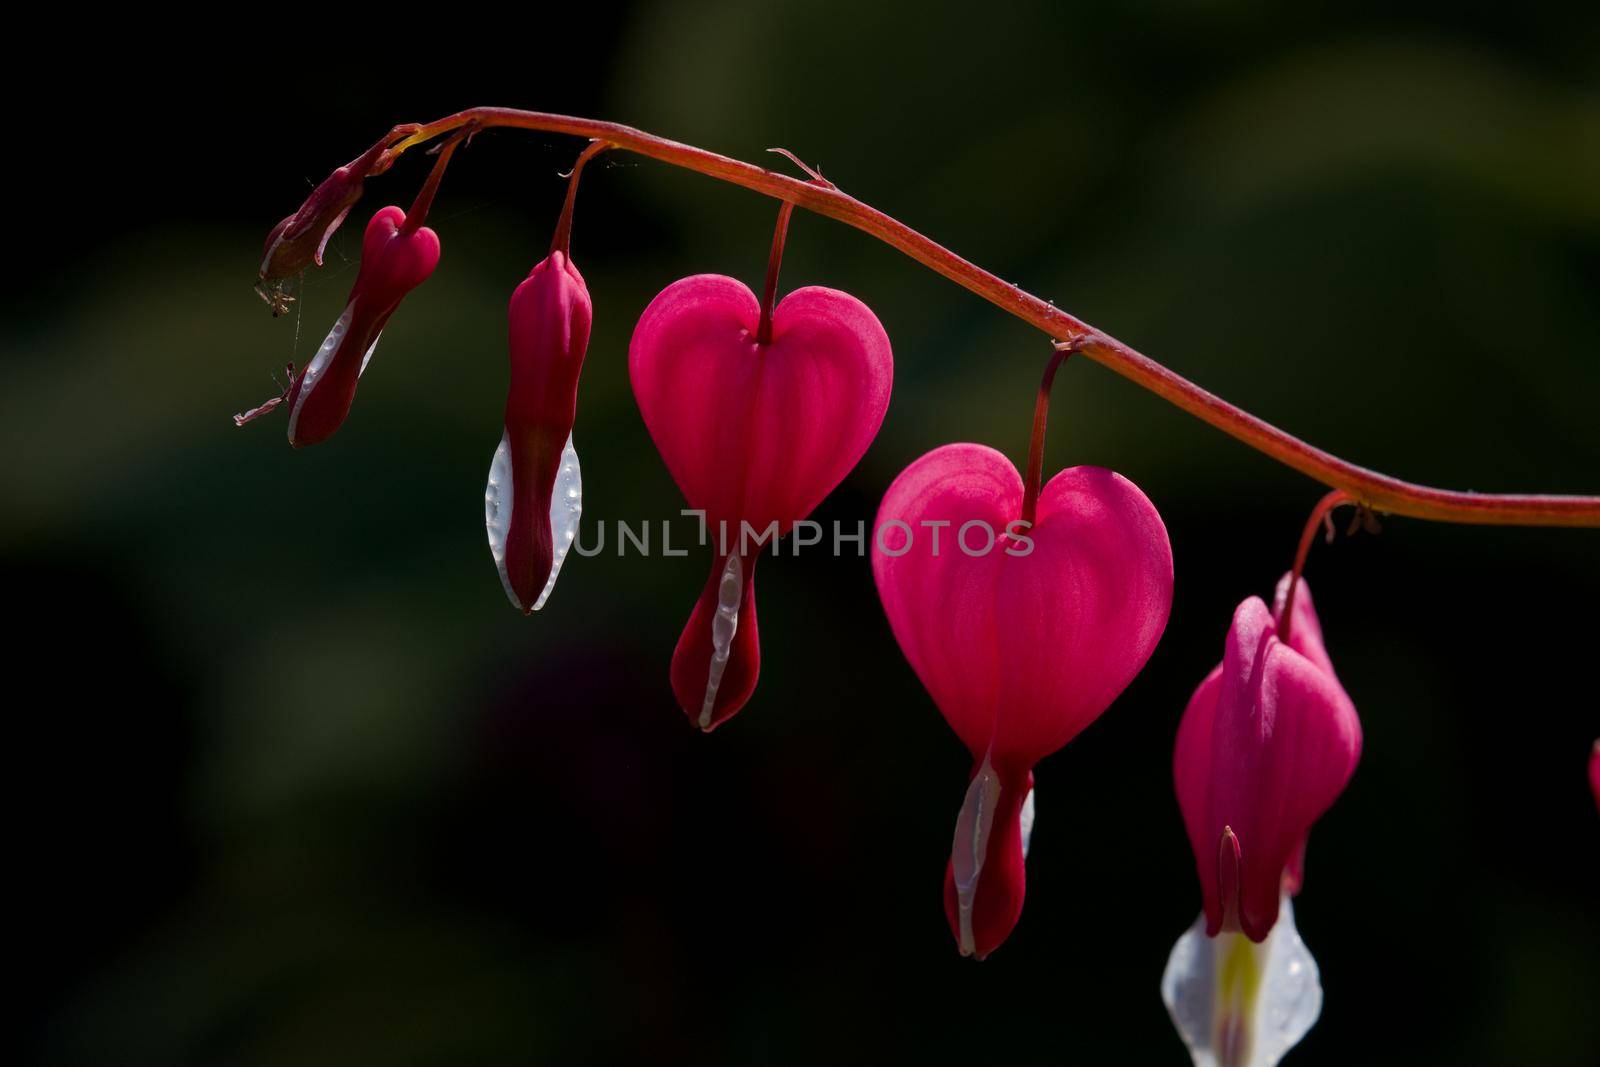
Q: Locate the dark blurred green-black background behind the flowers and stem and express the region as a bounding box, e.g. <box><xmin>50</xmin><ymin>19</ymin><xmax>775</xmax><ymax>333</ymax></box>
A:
<box><xmin>0</xmin><ymin>0</ymin><xmax>1600</xmax><ymax>1067</ymax></box>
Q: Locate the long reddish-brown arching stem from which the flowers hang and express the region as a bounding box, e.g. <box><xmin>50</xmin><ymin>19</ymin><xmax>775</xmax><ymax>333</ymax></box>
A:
<box><xmin>318</xmin><ymin>107</ymin><xmax>1600</xmax><ymax>526</ymax></box>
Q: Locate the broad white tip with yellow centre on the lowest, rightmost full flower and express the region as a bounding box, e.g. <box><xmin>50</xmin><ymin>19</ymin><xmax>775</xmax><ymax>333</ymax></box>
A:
<box><xmin>1162</xmin><ymin>894</ymin><xmax>1322</xmax><ymax>1067</ymax></box>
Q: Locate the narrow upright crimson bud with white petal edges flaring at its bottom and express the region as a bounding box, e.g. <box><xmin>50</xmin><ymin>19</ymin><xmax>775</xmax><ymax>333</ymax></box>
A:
<box><xmin>483</xmin><ymin>250</ymin><xmax>594</xmax><ymax>614</ymax></box>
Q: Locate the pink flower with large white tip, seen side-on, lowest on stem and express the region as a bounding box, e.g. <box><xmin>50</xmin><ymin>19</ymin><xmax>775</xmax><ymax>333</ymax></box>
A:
<box><xmin>1162</xmin><ymin>574</ymin><xmax>1362</xmax><ymax>1067</ymax></box>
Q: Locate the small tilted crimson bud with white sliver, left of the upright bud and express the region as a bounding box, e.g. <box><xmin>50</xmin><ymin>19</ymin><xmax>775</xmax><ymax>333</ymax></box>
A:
<box><xmin>285</xmin><ymin>206</ymin><xmax>438</xmax><ymax>448</ymax></box>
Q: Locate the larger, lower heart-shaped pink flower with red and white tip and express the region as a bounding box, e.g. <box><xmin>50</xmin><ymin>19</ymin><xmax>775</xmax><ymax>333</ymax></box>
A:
<box><xmin>872</xmin><ymin>445</ymin><xmax>1173</xmax><ymax>958</ymax></box>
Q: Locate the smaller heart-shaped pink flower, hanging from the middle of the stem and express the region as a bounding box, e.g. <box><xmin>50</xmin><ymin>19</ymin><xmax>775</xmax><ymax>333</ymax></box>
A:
<box><xmin>629</xmin><ymin>274</ymin><xmax>894</xmax><ymax>731</ymax></box>
